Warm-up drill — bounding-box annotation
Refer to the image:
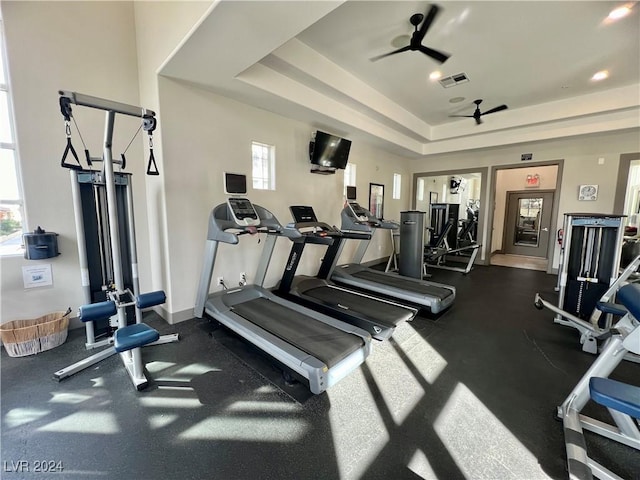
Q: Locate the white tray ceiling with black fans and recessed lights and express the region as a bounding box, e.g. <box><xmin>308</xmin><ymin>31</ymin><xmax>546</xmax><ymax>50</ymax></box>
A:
<box><xmin>160</xmin><ymin>0</ymin><xmax>640</xmax><ymax>157</ymax></box>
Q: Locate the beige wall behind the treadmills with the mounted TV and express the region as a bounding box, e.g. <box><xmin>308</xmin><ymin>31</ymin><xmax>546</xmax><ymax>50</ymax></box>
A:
<box><xmin>160</xmin><ymin>78</ymin><xmax>410</xmax><ymax>321</ymax></box>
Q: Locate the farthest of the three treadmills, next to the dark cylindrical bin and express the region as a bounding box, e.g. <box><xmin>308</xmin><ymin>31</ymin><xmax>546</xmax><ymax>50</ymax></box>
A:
<box><xmin>329</xmin><ymin>201</ymin><xmax>456</xmax><ymax>314</ymax></box>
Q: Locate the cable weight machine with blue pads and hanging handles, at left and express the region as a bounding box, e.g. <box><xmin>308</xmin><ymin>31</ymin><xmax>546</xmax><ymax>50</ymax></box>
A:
<box><xmin>54</xmin><ymin>91</ymin><xmax>178</xmax><ymax>390</ymax></box>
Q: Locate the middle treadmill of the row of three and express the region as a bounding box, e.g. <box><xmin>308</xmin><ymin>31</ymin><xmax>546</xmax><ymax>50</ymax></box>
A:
<box><xmin>276</xmin><ymin>206</ymin><xmax>418</xmax><ymax>340</ymax></box>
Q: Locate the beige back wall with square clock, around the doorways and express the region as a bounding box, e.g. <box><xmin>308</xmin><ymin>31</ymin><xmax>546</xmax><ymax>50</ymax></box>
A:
<box><xmin>409</xmin><ymin>129</ymin><xmax>640</xmax><ymax>267</ymax></box>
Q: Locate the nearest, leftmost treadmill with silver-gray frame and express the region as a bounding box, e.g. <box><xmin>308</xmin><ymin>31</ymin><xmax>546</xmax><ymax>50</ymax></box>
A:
<box><xmin>194</xmin><ymin>197</ymin><xmax>371</xmax><ymax>394</ymax></box>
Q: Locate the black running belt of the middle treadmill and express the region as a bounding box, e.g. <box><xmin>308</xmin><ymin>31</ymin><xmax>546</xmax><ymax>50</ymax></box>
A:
<box><xmin>303</xmin><ymin>286</ymin><xmax>414</xmax><ymax>327</ymax></box>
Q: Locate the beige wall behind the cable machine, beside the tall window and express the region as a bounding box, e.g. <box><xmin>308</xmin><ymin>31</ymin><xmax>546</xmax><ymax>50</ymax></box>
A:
<box><xmin>0</xmin><ymin>1</ymin><xmax>144</xmax><ymax>322</ymax></box>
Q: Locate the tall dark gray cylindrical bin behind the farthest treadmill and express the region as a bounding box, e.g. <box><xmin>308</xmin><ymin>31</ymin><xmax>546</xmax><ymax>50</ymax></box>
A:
<box><xmin>398</xmin><ymin>210</ymin><xmax>425</xmax><ymax>279</ymax></box>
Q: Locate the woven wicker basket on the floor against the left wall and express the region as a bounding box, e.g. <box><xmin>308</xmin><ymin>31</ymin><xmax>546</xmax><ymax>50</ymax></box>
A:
<box><xmin>0</xmin><ymin>309</ymin><xmax>71</xmax><ymax>357</ymax></box>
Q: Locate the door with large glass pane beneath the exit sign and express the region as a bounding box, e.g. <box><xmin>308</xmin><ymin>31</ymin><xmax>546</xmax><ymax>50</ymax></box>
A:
<box><xmin>503</xmin><ymin>190</ymin><xmax>553</xmax><ymax>258</ymax></box>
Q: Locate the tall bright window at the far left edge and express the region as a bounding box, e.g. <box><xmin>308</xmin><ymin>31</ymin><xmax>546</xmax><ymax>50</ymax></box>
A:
<box><xmin>0</xmin><ymin>19</ymin><xmax>24</xmax><ymax>255</ymax></box>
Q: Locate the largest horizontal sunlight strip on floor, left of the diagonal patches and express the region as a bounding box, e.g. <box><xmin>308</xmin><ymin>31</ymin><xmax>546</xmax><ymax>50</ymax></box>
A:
<box><xmin>178</xmin><ymin>416</ymin><xmax>309</xmax><ymax>443</ymax></box>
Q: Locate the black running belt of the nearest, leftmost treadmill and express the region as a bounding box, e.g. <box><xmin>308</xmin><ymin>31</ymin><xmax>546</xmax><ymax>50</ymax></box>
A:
<box><xmin>233</xmin><ymin>297</ymin><xmax>364</xmax><ymax>368</ymax></box>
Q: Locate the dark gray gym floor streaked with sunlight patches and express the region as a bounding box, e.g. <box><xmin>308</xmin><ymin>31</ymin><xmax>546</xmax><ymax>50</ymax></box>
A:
<box><xmin>0</xmin><ymin>266</ymin><xmax>640</xmax><ymax>480</ymax></box>
